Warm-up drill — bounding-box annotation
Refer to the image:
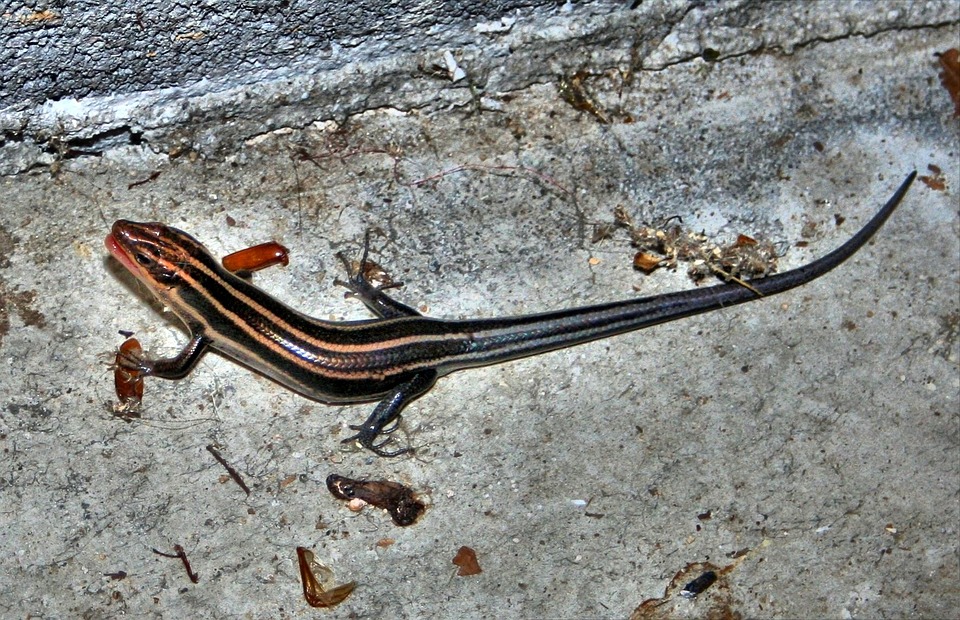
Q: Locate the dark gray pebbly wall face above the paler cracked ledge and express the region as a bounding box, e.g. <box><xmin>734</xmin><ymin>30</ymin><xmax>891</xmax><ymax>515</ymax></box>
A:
<box><xmin>0</xmin><ymin>0</ymin><xmax>556</xmax><ymax>109</ymax></box>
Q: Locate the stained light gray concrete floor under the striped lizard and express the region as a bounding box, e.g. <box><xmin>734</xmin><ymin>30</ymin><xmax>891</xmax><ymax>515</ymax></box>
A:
<box><xmin>0</xmin><ymin>3</ymin><xmax>960</xmax><ymax>618</ymax></box>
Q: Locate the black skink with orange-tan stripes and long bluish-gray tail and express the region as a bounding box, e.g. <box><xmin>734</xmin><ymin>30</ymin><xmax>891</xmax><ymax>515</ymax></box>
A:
<box><xmin>106</xmin><ymin>172</ymin><xmax>916</xmax><ymax>456</ymax></box>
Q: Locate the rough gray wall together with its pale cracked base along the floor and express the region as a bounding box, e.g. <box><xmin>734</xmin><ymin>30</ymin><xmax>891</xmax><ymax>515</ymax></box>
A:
<box><xmin>0</xmin><ymin>0</ymin><xmax>955</xmax><ymax>174</ymax></box>
